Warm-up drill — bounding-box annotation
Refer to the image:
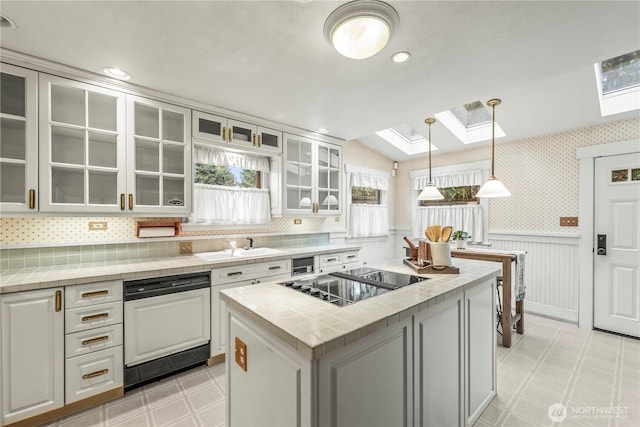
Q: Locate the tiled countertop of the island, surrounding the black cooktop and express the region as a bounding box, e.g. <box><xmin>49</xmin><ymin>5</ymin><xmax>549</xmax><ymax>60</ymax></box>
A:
<box><xmin>220</xmin><ymin>259</ymin><xmax>501</xmax><ymax>359</ymax></box>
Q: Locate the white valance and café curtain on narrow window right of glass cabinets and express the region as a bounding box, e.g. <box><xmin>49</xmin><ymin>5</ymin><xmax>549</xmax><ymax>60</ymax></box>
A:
<box><xmin>345</xmin><ymin>165</ymin><xmax>390</xmax><ymax>237</ymax></box>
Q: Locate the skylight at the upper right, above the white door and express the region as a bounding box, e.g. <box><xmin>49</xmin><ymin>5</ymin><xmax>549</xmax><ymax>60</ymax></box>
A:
<box><xmin>594</xmin><ymin>50</ymin><xmax>640</xmax><ymax>116</ymax></box>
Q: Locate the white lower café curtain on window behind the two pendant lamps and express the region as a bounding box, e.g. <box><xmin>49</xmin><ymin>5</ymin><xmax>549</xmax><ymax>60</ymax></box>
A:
<box><xmin>413</xmin><ymin>205</ymin><xmax>486</xmax><ymax>242</ymax></box>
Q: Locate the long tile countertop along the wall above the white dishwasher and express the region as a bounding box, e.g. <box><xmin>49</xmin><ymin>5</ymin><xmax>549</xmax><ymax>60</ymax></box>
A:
<box><xmin>0</xmin><ymin>245</ymin><xmax>360</xmax><ymax>294</ymax></box>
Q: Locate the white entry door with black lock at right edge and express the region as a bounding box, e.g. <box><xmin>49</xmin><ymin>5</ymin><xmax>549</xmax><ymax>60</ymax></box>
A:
<box><xmin>593</xmin><ymin>153</ymin><xmax>640</xmax><ymax>337</ymax></box>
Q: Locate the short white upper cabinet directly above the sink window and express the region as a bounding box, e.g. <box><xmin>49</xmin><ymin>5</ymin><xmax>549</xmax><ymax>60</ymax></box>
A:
<box><xmin>192</xmin><ymin>111</ymin><xmax>282</xmax><ymax>154</ymax></box>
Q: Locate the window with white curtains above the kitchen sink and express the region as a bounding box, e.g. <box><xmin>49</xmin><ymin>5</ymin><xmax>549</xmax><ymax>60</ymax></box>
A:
<box><xmin>190</xmin><ymin>144</ymin><xmax>271</xmax><ymax>226</ymax></box>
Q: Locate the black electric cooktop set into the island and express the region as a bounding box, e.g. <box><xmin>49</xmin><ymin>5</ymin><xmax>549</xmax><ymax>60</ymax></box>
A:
<box><xmin>280</xmin><ymin>267</ymin><xmax>428</xmax><ymax>306</ymax></box>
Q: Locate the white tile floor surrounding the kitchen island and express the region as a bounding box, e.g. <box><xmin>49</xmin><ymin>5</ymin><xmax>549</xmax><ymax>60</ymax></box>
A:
<box><xmin>42</xmin><ymin>315</ymin><xmax>640</xmax><ymax>427</ymax></box>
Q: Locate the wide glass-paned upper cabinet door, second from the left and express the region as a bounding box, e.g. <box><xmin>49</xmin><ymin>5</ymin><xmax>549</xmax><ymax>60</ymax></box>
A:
<box><xmin>39</xmin><ymin>74</ymin><xmax>127</xmax><ymax>212</ymax></box>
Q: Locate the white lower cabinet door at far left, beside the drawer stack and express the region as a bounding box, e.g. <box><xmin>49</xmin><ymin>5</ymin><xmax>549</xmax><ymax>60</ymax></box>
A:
<box><xmin>0</xmin><ymin>288</ymin><xmax>64</xmax><ymax>425</ymax></box>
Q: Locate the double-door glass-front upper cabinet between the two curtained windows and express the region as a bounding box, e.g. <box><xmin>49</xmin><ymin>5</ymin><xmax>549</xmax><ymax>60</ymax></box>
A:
<box><xmin>283</xmin><ymin>135</ymin><xmax>342</xmax><ymax>215</ymax></box>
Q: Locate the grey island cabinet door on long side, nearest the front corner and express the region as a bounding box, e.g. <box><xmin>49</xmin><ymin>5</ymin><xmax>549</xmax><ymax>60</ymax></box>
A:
<box><xmin>317</xmin><ymin>318</ymin><xmax>413</xmax><ymax>427</ymax></box>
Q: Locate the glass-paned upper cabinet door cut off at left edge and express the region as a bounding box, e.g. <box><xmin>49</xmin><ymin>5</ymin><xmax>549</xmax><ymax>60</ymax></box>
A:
<box><xmin>0</xmin><ymin>64</ymin><xmax>38</xmax><ymax>212</ymax></box>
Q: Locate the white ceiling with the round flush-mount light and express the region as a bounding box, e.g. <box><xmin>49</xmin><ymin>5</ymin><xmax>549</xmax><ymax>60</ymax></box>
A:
<box><xmin>0</xmin><ymin>0</ymin><xmax>640</xmax><ymax>160</ymax></box>
